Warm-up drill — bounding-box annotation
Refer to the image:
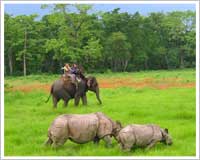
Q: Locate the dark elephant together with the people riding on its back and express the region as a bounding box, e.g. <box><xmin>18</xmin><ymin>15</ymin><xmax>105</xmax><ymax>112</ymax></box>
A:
<box><xmin>46</xmin><ymin>64</ymin><xmax>102</xmax><ymax>107</ymax></box>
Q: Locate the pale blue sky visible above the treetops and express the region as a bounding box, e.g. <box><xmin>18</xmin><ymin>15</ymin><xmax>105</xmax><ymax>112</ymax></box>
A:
<box><xmin>4</xmin><ymin>4</ymin><xmax>195</xmax><ymax>17</ymax></box>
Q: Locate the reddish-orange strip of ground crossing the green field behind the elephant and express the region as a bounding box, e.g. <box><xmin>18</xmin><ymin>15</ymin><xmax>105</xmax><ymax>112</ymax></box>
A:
<box><xmin>5</xmin><ymin>78</ymin><xmax>195</xmax><ymax>92</ymax></box>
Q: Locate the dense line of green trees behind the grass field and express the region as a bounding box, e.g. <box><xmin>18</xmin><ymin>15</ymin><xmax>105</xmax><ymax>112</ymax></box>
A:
<box><xmin>4</xmin><ymin>4</ymin><xmax>196</xmax><ymax>75</ymax></box>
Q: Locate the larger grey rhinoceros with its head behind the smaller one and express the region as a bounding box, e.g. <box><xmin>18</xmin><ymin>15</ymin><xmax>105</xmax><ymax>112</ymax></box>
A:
<box><xmin>45</xmin><ymin>112</ymin><xmax>121</xmax><ymax>148</ymax></box>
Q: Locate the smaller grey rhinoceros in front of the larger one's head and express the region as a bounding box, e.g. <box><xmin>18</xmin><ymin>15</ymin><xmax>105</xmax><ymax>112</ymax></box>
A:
<box><xmin>116</xmin><ymin>124</ymin><xmax>172</xmax><ymax>151</ymax></box>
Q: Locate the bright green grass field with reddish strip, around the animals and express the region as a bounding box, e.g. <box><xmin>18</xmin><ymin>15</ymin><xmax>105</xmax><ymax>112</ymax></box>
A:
<box><xmin>4</xmin><ymin>69</ymin><xmax>196</xmax><ymax>156</ymax></box>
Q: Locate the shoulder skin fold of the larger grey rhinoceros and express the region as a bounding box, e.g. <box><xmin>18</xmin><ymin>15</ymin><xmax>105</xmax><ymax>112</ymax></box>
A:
<box><xmin>96</xmin><ymin>112</ymin><xmax>113</xmax><ymax>138</ymax></box>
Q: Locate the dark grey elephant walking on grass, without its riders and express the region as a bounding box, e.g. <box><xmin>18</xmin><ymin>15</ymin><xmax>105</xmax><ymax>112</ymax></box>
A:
<box><xmin>46</xmin><ymin>76</ymin><xmax>102</xmax><ymax>108</ymax></box>
